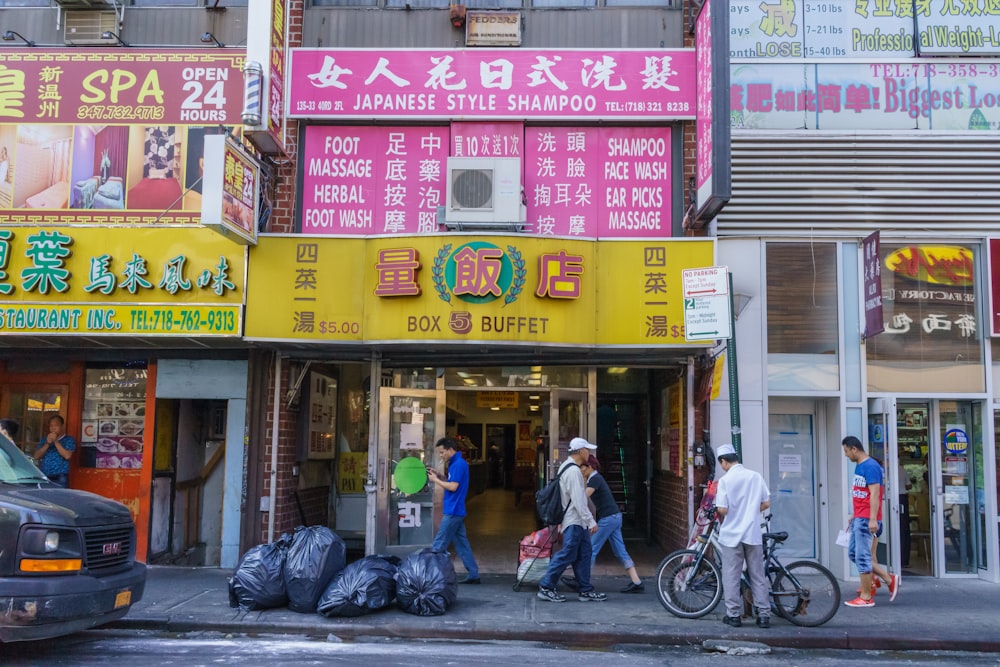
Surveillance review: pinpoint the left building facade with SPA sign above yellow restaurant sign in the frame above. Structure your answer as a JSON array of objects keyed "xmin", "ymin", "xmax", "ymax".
[{"xmin": 0, "ymin": 14, "xmax": 254, "ymax": 567}]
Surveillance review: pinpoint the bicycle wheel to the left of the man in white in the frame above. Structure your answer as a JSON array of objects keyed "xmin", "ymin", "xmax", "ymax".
[{"xmin": 656, "ymin": 549, "xmax": 722, "ymax": 618}]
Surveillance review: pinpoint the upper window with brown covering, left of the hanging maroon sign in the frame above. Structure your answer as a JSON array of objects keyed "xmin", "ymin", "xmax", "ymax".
[{"xmin": 767, "ymin": 243, "xmax": 840, "ymax": 391}]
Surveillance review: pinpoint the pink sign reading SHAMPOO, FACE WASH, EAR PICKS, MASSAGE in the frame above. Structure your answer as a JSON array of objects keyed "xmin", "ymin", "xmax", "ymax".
[{"xmin": 524, "ymin": 127, "xmax": 671, "ymax": 239}]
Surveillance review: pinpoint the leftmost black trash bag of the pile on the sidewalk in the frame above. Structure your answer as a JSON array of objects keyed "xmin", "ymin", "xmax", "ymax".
[{"xmin": 229, "ymin": 533, "xmax": 292, "ymax": 611}]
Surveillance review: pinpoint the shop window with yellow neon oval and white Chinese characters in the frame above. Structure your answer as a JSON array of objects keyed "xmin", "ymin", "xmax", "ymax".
[{"xmin": 865, "ymin": 240, "xmax": 986, "ymax": 392}]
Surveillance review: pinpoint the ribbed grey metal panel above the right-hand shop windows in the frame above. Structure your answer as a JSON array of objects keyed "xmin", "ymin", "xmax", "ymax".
[{"xmin": 717, "ymin": 131, "xmax": 1000, "ymax": 237}]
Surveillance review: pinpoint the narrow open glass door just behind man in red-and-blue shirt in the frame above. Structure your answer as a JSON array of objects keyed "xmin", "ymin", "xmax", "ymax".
[{"xmin": 868, "ymin": 398, "xmax": 909, "ymax": 572}]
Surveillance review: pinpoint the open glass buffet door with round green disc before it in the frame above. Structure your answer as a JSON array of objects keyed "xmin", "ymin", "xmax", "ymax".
[{"xmin": 375, "ymin": 387, "xmax": 444, "ymax": 556}]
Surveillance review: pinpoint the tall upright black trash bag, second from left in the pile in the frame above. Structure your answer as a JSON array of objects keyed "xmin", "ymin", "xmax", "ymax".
[{"xmin": 285, "ymin": 526, "xmax": 347, "ymax": 614}]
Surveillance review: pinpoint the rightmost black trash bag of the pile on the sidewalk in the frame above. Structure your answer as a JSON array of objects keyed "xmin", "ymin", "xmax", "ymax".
[{"xmin": 396, "ymin": 548, "xmax": 458, "ymax": 616}]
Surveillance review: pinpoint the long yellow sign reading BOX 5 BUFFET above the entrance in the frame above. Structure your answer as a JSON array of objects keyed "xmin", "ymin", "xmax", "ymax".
[{"xmin": 246, "ymin": 235, "xmax": 715, "ymax": 346}]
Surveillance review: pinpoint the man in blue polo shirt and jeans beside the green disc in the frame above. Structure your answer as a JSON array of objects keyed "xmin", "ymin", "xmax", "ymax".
[{"xmin": 427, "ymin": 438, "xmax": 480, "ymax": 584}]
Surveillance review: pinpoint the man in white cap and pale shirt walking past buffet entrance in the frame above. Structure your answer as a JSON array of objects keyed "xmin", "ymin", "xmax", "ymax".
[{"xmin": 538, "ymin": 438, "xmax": 608, "ymax": 602}]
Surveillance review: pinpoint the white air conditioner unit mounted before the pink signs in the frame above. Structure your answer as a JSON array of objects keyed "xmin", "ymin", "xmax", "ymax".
[{"xmin": 444, "ymin": 157, "xmax": 525, "ymax": 223}]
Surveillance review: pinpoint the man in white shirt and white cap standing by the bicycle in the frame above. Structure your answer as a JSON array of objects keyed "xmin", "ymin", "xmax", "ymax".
[{"xmin": 715, "ymin": 444, "xmax": 771, "ymax": 628}]
